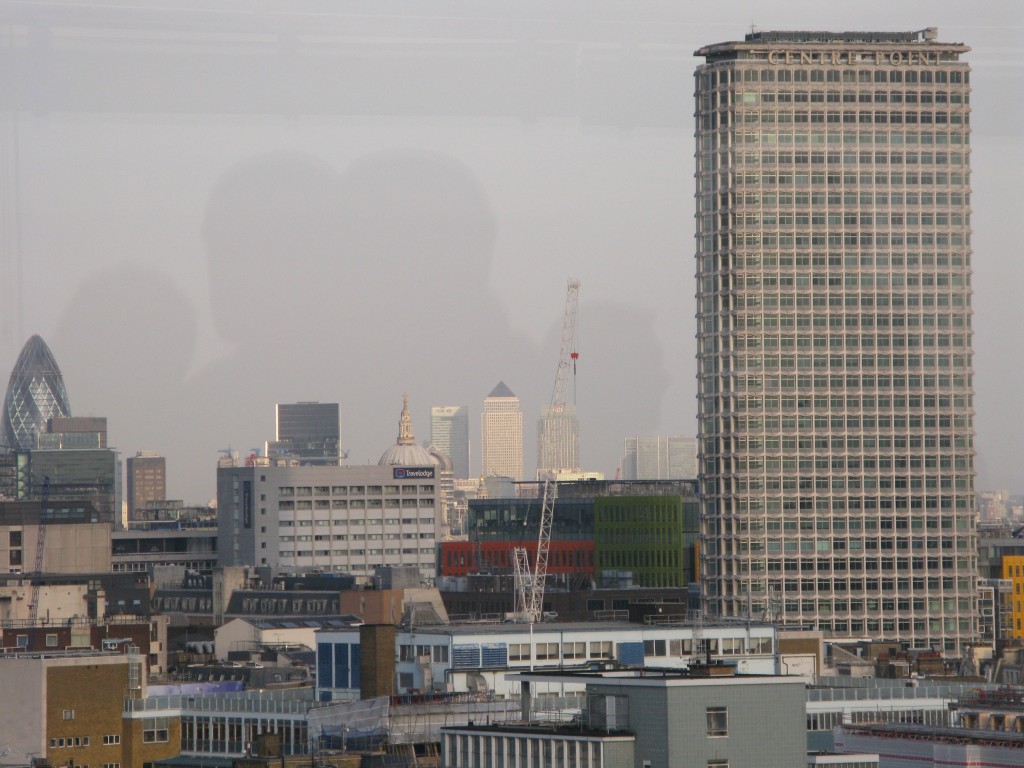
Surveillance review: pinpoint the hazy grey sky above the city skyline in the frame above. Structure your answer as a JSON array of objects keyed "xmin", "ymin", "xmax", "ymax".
[{"xmin": 0, "ymin": 0, "xmax": 1024, "ymax": 502}]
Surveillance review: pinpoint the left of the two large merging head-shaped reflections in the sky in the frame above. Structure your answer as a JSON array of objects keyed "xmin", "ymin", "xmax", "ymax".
[{"xmin": 203, "ymin": 153, "xmax": 341, "ymax": 340}]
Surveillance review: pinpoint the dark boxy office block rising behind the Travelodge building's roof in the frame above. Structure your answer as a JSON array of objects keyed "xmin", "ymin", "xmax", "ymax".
[{"xmin": 266, "ymin": 402, "xmax": 342, "ymax": 466}]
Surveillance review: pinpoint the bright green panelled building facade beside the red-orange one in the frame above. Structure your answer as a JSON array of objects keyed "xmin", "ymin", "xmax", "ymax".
[{"xmin": 594, "ymin": 493, "xmax": 700, "ymax": 587}]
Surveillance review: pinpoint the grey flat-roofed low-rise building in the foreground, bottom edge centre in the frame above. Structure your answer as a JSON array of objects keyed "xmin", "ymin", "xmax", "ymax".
[{"xmin": 441, "ymin": 666, "xmax": 807, "ymax": 768}]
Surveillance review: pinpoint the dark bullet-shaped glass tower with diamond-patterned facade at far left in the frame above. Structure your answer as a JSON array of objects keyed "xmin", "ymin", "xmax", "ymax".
[{"xmin": 2, "ymin": 336, "xmax": 71, "ymax": 451}]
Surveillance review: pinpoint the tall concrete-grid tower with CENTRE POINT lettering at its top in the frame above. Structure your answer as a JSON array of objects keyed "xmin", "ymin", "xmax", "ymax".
[{"xmin": 695, "ymin": 29, "xmax": 977, "ymax": 653}]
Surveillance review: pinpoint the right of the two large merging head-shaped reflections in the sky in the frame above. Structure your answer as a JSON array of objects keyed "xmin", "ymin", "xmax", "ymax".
[{"xmin": 342, "ymin": 150, "xmax": 495, "ymax": 290}]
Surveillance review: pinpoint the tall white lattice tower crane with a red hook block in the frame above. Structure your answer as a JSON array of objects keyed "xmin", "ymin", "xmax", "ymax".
[{"xmin": 512, "ymin": 280, "xmax": 580, "ymax": 624}]
